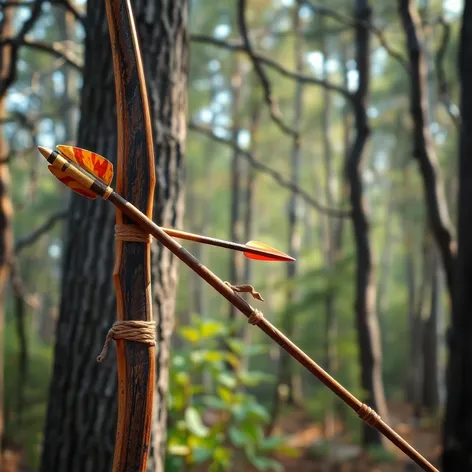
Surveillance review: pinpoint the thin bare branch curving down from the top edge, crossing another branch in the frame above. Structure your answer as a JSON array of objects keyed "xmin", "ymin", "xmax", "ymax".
[{"xmin": 238, "ymin": 0, "xmax": 298, "ymax": 139}]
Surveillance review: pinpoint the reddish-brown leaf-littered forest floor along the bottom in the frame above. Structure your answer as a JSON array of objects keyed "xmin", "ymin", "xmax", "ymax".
[{"xmin": 0, "ymin": 404, "xmax": 441, "ymax": 472}]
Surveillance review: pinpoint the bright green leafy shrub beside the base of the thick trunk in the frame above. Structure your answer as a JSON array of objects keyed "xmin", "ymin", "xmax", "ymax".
[{"xmin": 166, "ymin": 316, "xmax": 290, "ymax": 472}]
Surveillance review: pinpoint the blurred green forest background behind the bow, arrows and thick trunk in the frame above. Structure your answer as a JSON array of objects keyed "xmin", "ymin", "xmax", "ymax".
[{"xmin": 0, "ymin": 0, "xmax": 472, "ymax": 472}]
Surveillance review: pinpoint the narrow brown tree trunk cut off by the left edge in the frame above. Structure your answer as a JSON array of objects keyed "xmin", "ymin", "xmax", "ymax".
[{"xmin": 0, "ymin": 2, "xmax": 14, "ymax": 454}]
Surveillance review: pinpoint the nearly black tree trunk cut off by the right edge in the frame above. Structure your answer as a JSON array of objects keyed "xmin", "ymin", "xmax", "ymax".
[{"xmin": 441, "ymin": 1, "xmax": 472, "ymax": 472}]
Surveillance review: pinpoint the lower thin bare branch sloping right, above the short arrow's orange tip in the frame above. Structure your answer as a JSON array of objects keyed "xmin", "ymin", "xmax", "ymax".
[{"xmin": 189, "ymin": 122, "xmax": 351, "ymax": 218}]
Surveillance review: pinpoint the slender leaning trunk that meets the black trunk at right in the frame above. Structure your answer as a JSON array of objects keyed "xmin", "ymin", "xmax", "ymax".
[{"xmin": 398, "ymin": 0, "xmax": 456, "ymax": 299}]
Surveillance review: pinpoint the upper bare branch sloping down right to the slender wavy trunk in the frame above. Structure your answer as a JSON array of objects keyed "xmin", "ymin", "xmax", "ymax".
[{"xmin": 190, "ymin": 34, "xmax": 352, "ymax": 102}]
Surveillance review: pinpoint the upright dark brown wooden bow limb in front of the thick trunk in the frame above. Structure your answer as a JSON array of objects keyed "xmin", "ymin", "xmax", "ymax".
[{"xmin": 105, "ymin": 0, "xmax": 155, "ymax": 472}]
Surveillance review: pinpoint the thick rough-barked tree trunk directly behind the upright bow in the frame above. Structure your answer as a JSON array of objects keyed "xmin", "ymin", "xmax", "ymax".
[{"xmin": 41, "ymin": 0, "xmax": 187, "ymax": 472}]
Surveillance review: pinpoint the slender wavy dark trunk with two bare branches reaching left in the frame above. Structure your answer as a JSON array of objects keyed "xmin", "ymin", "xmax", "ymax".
[{"xmin": 346, "ymin": 0, "xmax": 388, "ymax": 445}]
